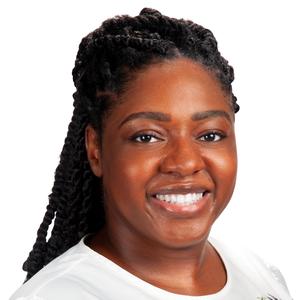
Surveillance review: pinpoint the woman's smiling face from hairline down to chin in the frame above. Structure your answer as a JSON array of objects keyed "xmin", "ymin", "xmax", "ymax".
[{"xmin": 87, "ymin": 58, "xmax": 237, "ymax": 248}]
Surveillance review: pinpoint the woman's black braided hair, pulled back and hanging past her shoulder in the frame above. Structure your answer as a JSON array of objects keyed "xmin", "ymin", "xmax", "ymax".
[{"xmin": 23, "ymin": 8, "xmax": 239, "ymax": 280}]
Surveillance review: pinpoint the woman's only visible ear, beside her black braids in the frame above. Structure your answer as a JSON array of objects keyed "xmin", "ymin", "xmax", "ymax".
[{"xmin": 85, "ymin": 125, "xmax": 102, "ymax": 177}]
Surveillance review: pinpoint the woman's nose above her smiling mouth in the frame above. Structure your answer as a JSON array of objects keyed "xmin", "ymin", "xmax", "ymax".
[{"xmin": 160, "ymin": 140, "xmax": 205, "ymax": 177}]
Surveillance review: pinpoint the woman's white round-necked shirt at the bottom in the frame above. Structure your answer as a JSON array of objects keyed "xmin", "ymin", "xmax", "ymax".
[{"xmin": 10, "ymin": 239, "xmax": 292, "ymax": 300}]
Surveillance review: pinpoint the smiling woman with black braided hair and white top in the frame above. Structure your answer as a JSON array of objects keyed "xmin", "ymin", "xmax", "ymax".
[{"xmin": 11, "ymin": 8, "xmax": 291, "ymax": 300}]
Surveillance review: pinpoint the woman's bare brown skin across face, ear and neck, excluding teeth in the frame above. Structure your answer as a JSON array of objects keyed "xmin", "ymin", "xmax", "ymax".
[{"xmin": 86, "ymin": 58, "xmax": 237, "ymax": 295}]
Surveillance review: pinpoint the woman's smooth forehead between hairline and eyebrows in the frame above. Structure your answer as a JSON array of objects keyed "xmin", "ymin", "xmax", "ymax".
[{"xmin": 111, "ymin": 58, "xmax": 233, "ymax": 122}]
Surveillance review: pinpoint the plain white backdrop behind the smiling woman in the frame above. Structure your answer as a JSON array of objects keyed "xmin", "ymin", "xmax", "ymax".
[{"xmin": 0, "ymin": 0, "xmax": 300, "ymax": 299}]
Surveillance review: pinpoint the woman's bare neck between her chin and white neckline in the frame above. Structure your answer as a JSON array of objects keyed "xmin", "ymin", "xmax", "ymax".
[{"xmin": 89, "ymin": 227, "xmax": 226, "ymax": 295}]
